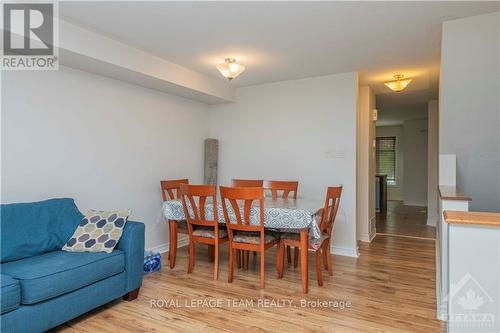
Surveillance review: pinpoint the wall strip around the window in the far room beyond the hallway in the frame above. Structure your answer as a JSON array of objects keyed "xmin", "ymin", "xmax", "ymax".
[{"xmin": 376, "ymin": 125, "xmax": 404, "ymax": 201}]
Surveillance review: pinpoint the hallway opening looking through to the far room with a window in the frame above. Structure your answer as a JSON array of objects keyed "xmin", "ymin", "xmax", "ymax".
[{"xmin": 375, "ymin": 105, "xmax": 436, "ymax": 239}]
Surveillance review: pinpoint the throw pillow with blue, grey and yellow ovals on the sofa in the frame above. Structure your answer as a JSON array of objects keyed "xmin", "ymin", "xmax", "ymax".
[{"xmin": 62, "ymin": 210, "xmax": 130, "ymax": 253}]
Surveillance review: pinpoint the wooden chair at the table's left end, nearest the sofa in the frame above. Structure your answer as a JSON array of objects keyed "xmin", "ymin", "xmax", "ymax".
[{"xmin": 160, "ymin": 179, "xmax": 189, "ymax": 268}]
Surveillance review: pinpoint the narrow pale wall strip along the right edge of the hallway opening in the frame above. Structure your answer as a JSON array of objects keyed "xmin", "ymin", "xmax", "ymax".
[{"xmin": 427, "ymin": 100, "xmax": 439, "ymax": 226}]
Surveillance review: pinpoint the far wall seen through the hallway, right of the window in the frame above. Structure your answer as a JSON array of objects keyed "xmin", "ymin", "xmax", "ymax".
[{"xmin": 403, "ymin": 119, "xmax": 428, "ymax": 206}]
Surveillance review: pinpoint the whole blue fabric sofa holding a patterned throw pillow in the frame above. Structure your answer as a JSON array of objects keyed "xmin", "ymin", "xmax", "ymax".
[{"xmin": 0, "ymin": 199, "xmax": 144, "ymax": 332}]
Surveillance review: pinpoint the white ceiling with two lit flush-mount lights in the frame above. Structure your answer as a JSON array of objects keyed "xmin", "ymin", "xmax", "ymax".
[{"xmin": 59, "ymin": 2, "xmax": 500, "ymax": 113}]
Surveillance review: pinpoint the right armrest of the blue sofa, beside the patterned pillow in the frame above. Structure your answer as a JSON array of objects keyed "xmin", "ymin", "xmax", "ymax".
[{"xmin": 116, "ymin": 221, "xmax": 145, "ymax": 292}]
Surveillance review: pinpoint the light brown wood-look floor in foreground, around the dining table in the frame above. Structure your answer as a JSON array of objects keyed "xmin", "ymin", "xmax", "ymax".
[{"xmin": 54, "ymin": 235, "xmax": 445, "ymax": 333}]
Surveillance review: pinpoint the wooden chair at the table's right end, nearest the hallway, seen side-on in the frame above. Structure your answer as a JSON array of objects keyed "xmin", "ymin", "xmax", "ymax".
[{"xmin": 277, "ymin": 186, "xmax": 342, "ymax": 286}]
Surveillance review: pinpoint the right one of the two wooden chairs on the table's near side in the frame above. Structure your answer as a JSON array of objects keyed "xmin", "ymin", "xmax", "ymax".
[{"xmin": 220, "ymin": 186, "xmax": 278, "ymax": 288}]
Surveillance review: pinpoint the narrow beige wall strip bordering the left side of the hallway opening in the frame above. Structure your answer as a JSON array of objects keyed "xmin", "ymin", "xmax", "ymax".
[{"xmin": 356, "ymin": 86, "xmax": 376, "ymax": 242}]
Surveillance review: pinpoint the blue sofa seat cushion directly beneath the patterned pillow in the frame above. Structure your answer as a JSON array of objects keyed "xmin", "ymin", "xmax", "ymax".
[{"xmin": 2, "ymin": 250, "xmax": 125, "ymax": 304}]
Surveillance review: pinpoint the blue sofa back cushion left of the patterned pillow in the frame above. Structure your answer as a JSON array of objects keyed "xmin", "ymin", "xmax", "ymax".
[{"xmin": 0, "ymin": 198, "xmax": 83, "ymax": 263}]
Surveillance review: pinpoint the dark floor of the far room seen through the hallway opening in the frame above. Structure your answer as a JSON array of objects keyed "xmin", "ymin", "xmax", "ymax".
[{"xmin": 377, "ymin": 201, "xmax": 436, "ymax": 239}]
